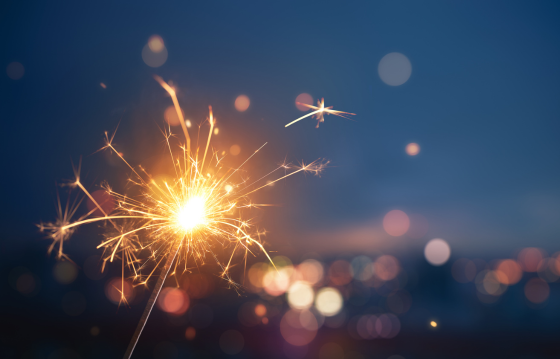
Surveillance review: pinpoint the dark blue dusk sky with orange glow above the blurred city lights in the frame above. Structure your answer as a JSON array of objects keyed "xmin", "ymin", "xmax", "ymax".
[{"xmin": 0, "ymin": 1, "xmax": 560, "ymax": 255}]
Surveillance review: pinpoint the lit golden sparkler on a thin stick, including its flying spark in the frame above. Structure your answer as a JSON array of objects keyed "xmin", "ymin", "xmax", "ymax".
[{"xmin": 39, "ymin": 76, "xmax": 332, "ymax": 358}]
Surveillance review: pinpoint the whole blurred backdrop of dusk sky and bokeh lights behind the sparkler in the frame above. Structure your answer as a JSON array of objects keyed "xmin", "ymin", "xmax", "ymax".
[{"xmin": 0, "ymin": 1, "xmax": 560, "ymax": 359}]
